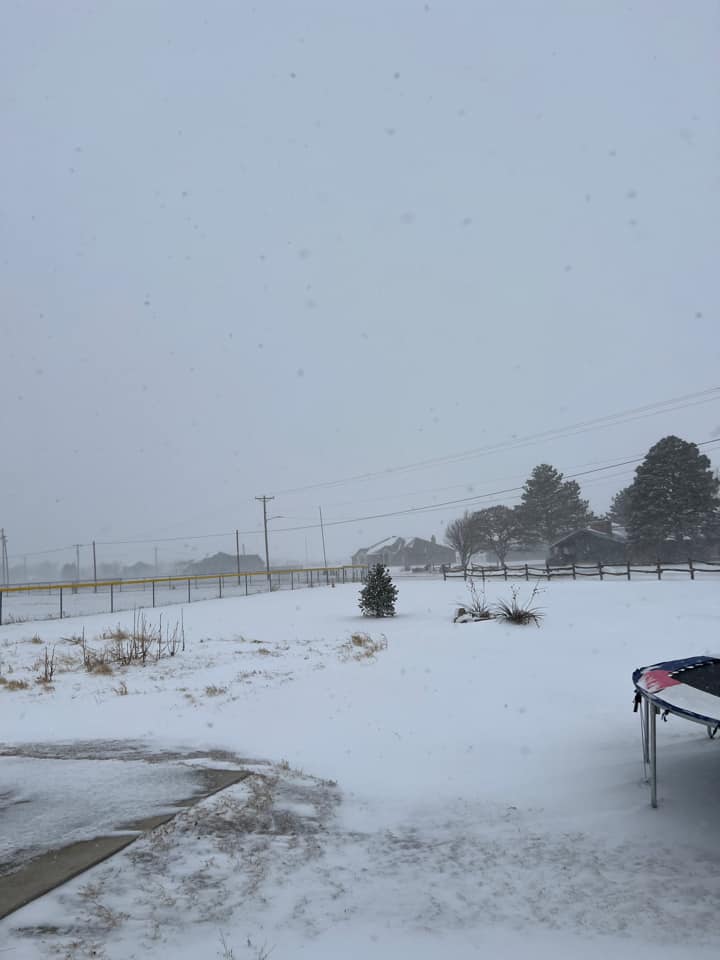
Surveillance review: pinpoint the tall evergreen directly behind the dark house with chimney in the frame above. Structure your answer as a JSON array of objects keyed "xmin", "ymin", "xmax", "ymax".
[{"xmin": 516, "ymin": 463, "xmax": 592, "ymax": 543}]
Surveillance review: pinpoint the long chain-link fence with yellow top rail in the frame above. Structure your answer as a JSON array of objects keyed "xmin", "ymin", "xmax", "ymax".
[{"xmin": 0, "ymin": 564, "xmax": 367, "ymax": 625}]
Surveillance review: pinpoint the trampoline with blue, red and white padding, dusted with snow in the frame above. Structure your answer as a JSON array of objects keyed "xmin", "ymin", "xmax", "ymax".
[{"xmin": 633, "ymin": 656, "xmax": 720, "ymax": 807}]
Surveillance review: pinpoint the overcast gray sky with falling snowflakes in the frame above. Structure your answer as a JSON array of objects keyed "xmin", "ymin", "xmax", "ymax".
[{"xmin": 0, "ymin": 0, "xmax": 720, "ymax": 560}]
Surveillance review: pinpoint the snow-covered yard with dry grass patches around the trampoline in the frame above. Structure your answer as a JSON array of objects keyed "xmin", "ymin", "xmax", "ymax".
[{"xmin": 0, "ymin": 581, "xmax": 720, "ymax": 960}]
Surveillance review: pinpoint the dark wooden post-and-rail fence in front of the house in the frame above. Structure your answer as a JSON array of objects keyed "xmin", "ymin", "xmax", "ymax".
[{"xmin": 443, "ymin": 560, "xmax": 720, "ymax": 583}]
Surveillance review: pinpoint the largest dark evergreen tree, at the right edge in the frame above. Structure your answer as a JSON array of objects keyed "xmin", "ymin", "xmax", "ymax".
[{"xmin": 628, "ymin": 436, "xmax": 718, "ymax": 557}]
